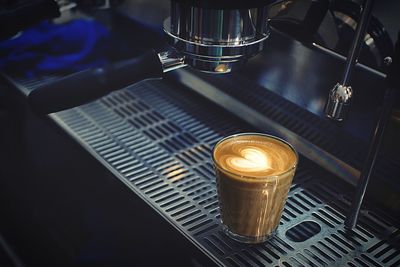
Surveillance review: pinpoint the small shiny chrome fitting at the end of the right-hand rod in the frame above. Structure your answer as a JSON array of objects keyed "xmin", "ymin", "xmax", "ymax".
[{"xmin": 325, "ymin": 83, "xmax": 353, "ymax": 121}]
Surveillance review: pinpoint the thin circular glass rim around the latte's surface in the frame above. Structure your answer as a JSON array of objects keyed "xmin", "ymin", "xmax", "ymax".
[{"xmin": 212, "ymin": 132, "xmax": 299, "ymax": 180}]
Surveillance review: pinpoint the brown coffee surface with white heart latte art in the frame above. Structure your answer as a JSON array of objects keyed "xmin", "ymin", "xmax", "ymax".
[{"xmin": 214, "ymin": 135, "xmax": 296, "ymax": 177}]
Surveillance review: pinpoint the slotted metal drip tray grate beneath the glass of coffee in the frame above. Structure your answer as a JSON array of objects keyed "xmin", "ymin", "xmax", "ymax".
[{"xmin": 51, "ymin": 81, "xmax": 400, "ymax": 266}]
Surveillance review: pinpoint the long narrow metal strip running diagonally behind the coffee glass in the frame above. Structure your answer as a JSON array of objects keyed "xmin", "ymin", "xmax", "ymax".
[{"xmin": 175, "ymin": 70, "xmax": 360, "ymax": 185}]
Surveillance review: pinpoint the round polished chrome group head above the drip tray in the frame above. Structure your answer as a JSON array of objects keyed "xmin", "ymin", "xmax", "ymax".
[{"xmin": 164, "ymin": 1, "xmax": 270, "ymax": 73}]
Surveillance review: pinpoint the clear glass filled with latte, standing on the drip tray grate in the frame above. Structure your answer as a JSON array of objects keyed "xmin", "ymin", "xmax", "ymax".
[{"xmin": 212, "ymin": 133, "xmax": 298, "ymax": 243}]
